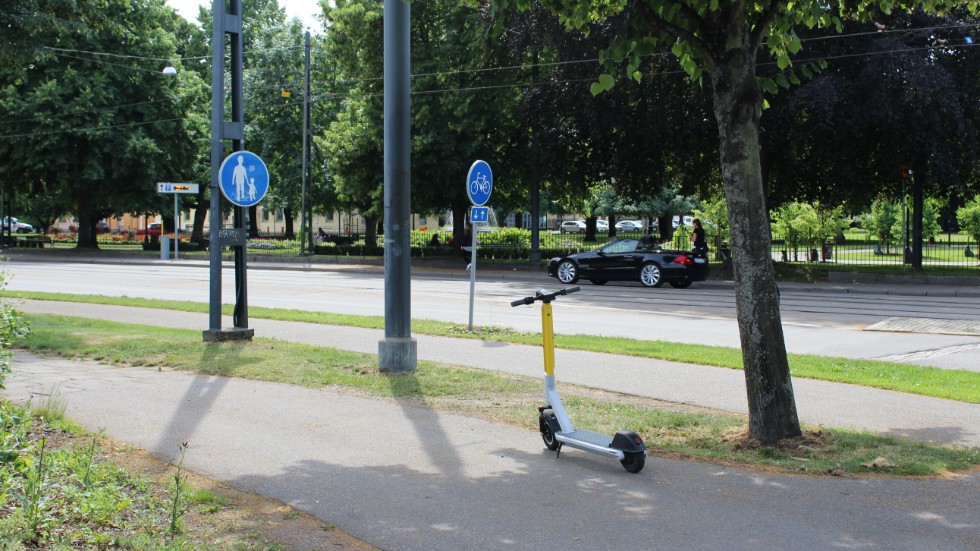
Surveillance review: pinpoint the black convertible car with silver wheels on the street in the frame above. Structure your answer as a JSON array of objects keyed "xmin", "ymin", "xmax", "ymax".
[{"xmin": 548, "ymin": 239, "xmax": 708, "ymax": 289}]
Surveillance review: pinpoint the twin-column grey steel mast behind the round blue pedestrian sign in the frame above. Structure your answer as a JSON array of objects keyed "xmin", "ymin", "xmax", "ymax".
[{"xmin": 204, "ymin": 0, "xmax": 255, "ymax": 342}]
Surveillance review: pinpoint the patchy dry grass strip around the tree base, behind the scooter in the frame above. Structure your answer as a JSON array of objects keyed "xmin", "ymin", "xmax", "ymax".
[{"xmin": 19, "ymin": 314, "xmax": 980, "ymax": 475}]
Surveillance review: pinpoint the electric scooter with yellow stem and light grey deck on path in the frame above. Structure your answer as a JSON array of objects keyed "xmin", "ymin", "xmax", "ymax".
[{"xmin": 510, "ymin": 287, "xmax": 647, "ymax": 473}]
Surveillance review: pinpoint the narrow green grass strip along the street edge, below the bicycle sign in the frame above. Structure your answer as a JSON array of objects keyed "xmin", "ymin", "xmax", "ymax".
[{"xmin": 7, "ymin": 291, "xmax": 980, "ymax": 404}]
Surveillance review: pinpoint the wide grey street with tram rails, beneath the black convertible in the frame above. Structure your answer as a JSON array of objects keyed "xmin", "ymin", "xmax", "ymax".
[{"xmin": 7, "ymin": 258, "xmax": 980, "ymax": 371}]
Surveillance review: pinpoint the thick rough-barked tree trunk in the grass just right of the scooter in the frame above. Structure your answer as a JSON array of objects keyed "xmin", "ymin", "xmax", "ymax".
[{"xmin": 711, "ymin": 38, "xmax": 800, "ymax": 443}]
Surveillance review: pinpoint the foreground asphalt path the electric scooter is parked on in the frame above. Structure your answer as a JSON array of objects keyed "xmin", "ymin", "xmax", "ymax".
[{"xmin": 5, "ymin": 353, "xmax": 980, "ymax": 551}]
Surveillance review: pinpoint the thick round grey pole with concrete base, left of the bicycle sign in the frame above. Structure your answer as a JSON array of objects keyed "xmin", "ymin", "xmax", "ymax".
[{"xmin": 378, "ymin": 0, "xmax": 417, "ymax": 372}]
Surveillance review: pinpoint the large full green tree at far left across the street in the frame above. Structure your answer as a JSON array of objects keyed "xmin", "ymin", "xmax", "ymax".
[{"xmin": 0, "ymin": 0, "xmax": 208, "ymax": 247}]
